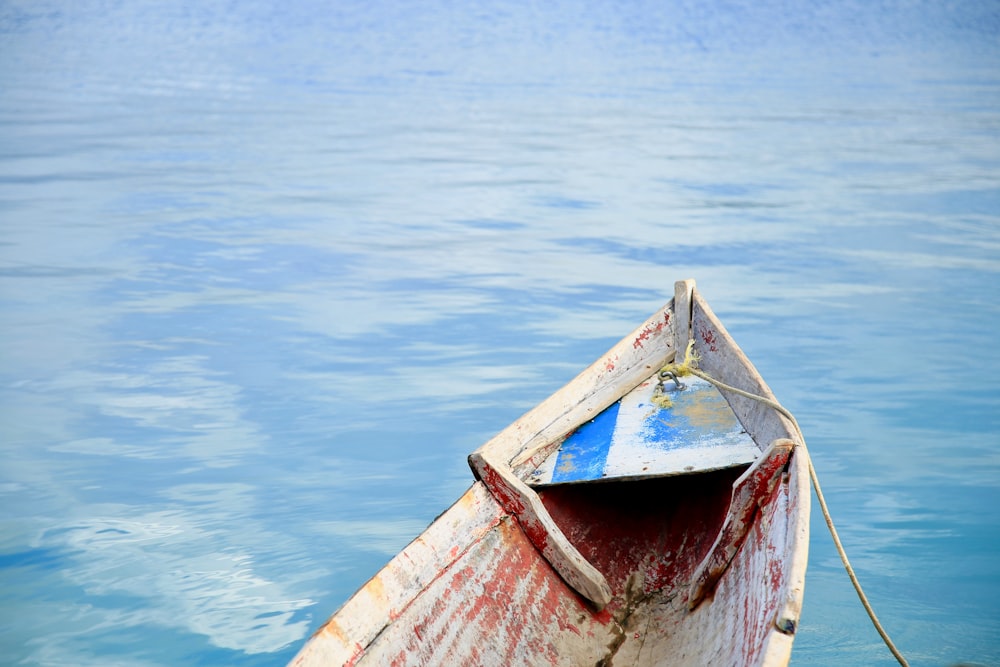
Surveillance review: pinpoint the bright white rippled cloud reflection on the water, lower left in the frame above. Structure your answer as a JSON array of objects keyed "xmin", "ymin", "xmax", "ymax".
[{"xmin": 38, "ymin": 508, "xmax": 312, "ymax": 653}]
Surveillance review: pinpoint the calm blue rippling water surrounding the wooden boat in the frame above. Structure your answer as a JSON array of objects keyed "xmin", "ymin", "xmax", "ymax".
[{"xmin": 0, "ymin": 0, "xmax": 1000, "ymax": 666}]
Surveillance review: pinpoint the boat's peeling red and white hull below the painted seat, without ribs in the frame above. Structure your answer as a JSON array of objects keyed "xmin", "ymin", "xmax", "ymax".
[{"xmin": 292, "ymin": 455, "xmax": 808, "ymax": 667}]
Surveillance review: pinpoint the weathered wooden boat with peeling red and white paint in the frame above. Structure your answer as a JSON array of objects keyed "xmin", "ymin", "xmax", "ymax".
[{"xmin": 290, "ymin": 280, "xmax": 810, "ymax": 667}]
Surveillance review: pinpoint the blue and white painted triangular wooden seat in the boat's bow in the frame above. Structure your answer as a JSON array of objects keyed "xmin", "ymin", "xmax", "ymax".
[{"xmin": 525, "ymin": 375, "xmax": 760, "ymax": 487}]
